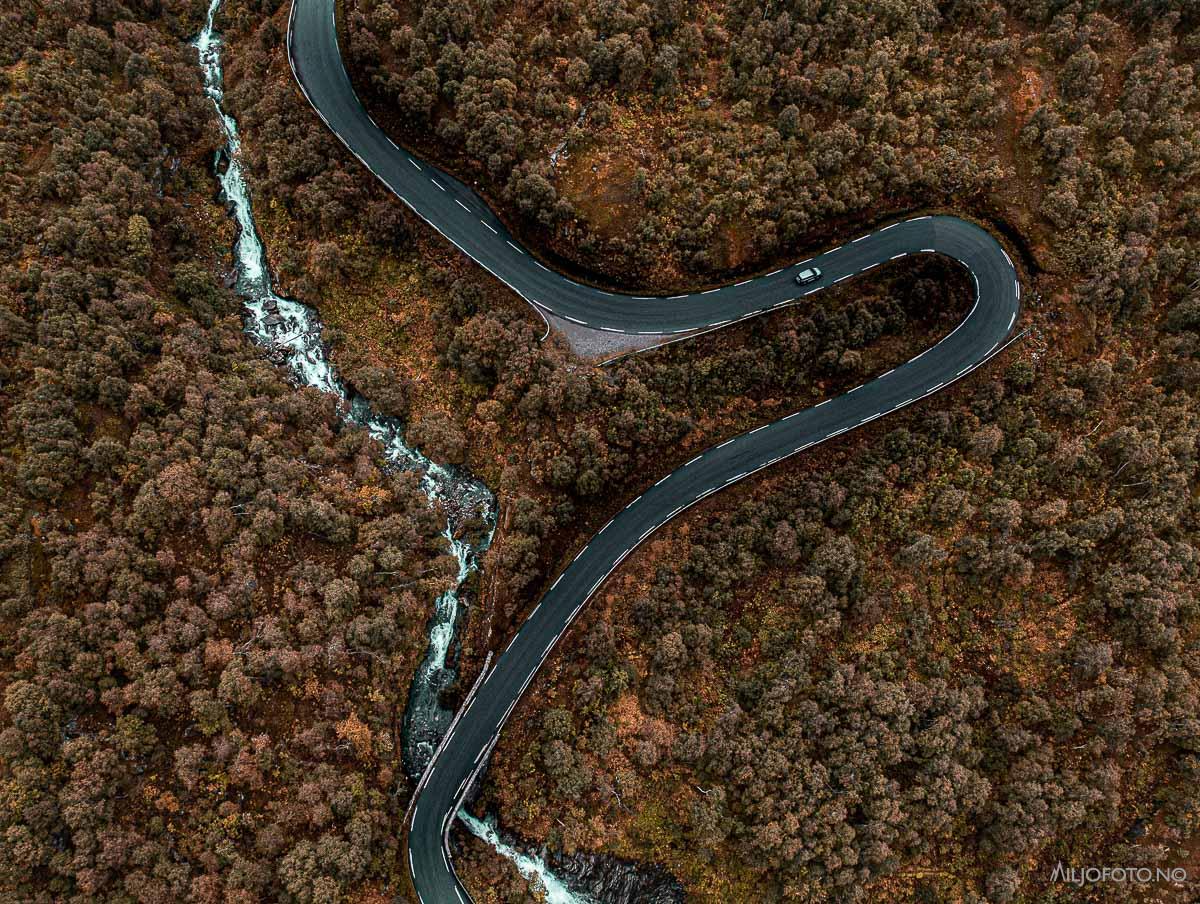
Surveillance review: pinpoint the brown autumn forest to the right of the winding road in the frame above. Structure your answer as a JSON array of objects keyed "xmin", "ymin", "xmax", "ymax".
[{"xmin": 331, "ymin": 0, "xmax": 1200, "ymax": 900}]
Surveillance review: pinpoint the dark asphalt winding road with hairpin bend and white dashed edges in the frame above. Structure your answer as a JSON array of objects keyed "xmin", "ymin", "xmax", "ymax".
[{"xmin": 287, "ymin": 0, "xmax": 1021, "ymax": 904}]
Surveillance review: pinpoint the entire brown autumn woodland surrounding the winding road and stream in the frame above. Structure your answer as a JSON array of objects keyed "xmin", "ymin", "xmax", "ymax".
[{"xmin": 0, "ymin": 0, "xmax": 1200, "ymax": 904}]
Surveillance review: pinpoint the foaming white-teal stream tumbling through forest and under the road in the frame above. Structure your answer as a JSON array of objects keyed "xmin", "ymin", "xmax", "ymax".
[{"xmin": 194, "ymin": 0, "xmax": 681, "ymax": 904}]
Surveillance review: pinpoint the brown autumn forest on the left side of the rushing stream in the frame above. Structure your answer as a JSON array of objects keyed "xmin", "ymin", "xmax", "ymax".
[{"xmin": 0, "ymin": 4, "xmax": 456, "ymax": 904}]
